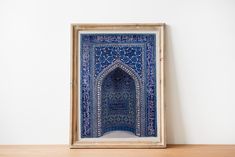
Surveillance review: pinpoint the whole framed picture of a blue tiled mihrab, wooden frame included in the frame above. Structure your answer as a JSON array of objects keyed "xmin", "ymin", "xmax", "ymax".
[{"xmin": 70, "ymin": 24, "xmax": 166, "ymax": 148}]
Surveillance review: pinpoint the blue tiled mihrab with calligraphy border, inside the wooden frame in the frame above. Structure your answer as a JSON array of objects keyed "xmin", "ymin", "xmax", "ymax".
[{"xmin": 79, "ymin": 32, "xmax": 158, "ymax": 138}]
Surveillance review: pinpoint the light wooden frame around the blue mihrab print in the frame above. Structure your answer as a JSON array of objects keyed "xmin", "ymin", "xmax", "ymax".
[{"xmin": 70, "ymin": 23, "xmax": 167, "ymax": 149}]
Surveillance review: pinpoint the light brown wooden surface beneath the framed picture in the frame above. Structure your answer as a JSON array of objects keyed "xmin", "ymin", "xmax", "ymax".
[{"xmin": 0, "ymin": 145, "xmax": 235, "ymax": 157}]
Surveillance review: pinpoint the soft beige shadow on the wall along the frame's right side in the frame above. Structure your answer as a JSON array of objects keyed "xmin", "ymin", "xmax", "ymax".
[{"xmin": 165, "ymin": 25, "xmax": 186, "ymax": 144}]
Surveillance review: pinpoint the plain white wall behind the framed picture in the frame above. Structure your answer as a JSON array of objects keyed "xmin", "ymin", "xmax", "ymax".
[{"xmin": 0, "ymin": 0, "xmax": 235, "ymax": 144}]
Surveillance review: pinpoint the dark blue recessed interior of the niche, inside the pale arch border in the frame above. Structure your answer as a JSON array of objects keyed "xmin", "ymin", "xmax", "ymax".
[{"xmin": 101, "ymin": 68, "xmax": 136, "ymax": 137}]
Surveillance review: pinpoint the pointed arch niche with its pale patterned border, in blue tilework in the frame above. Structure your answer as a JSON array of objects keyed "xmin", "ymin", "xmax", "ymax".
[{"xmin": 96, "ymin": 60, "xmax": 141, "ymax": 137}]
